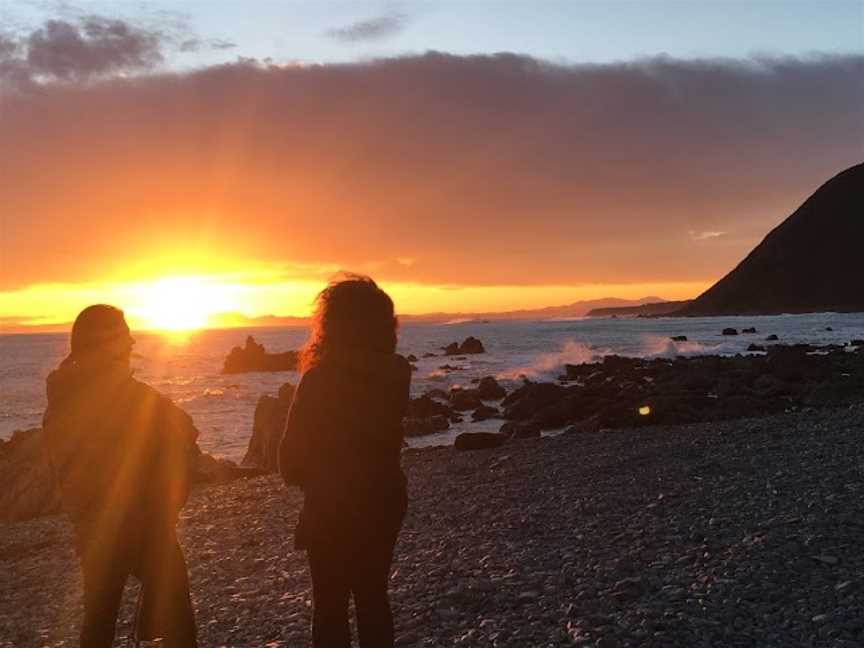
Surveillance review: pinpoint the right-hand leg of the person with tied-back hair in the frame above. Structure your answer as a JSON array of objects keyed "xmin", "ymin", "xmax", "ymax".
[{"xmin": 136, "ymin": 529, "xmax": 198, "ymax": 648}]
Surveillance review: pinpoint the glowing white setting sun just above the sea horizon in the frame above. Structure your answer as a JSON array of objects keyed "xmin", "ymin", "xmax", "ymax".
[{"xmin": 128, "ymin": 277, "xmax": 230, "ymax": 331}]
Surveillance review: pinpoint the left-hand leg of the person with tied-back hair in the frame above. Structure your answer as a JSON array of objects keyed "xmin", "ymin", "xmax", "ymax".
[{"xmin": 78, "ymin": 539, "xmax": 131, "ymax": 648}]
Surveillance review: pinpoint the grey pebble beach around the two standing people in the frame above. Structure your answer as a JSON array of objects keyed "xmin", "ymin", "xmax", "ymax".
[{"xmin": 0, "ymin": 405, "xmax": 864, "ymax": 648}]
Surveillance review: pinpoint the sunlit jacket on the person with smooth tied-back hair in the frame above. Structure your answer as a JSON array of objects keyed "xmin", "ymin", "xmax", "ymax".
[{"xmin": 43, "ymin": 361, "xmax": 198, "ymax": 534}]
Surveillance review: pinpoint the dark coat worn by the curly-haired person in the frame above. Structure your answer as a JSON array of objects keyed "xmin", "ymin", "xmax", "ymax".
[{"xmin": 279, "ymin": 351, "xmax": 411, "ymax": 549}]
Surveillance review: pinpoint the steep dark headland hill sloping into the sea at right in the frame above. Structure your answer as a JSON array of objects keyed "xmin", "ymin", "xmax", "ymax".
[{"xmin": 676, "ymin": 164, "xmax": 864, "ymax": 316}]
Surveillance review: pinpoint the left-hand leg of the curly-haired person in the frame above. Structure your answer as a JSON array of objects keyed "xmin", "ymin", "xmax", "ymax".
[{"xmin": 308, "ymin": 546, "xmax": 351, "ymax": 648}]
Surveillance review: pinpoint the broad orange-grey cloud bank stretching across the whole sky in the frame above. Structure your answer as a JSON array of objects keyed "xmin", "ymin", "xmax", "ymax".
[{"xmin": 0, "ymin": 53, "xmax": 864, "ymax": 288}]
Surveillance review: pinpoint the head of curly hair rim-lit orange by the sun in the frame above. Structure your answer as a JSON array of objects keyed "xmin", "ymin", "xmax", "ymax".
[{"xmin": 300, "ymin": 274, "xmax": 398, "ymax": 371}]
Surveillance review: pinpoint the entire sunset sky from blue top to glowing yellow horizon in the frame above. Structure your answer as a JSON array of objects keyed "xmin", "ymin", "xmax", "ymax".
[{"xmin": 0, "ymin": 0, "xmax": 864, "ymax": 332}]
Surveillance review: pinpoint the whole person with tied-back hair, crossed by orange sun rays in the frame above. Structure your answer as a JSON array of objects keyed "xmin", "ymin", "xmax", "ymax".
[{"xmin": 43, "ymin": 305, "xmax": 198, "ymax": 648}]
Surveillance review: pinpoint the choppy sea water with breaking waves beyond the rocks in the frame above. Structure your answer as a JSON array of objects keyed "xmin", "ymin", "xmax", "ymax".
[{"xmin": 0, "ymin": 313, "xmax": 864, "ymax": 460}]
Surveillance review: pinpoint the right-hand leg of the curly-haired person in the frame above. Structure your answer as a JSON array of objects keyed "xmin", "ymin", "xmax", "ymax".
[{"xmin": 351, "ymin": 534, "xmax": 396, "ymax": 648}]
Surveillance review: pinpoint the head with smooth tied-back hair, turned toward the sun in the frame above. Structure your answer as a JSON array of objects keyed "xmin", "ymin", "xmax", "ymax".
[{"xmin": 69, "ymin": 304, "xmax": 135, "ymax": 366}]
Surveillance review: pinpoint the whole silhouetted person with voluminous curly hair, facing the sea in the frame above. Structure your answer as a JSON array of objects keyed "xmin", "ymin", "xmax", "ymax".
[{"xmin": 279, "ymin": 275, "xmax": 411, "ymax": 648}]
